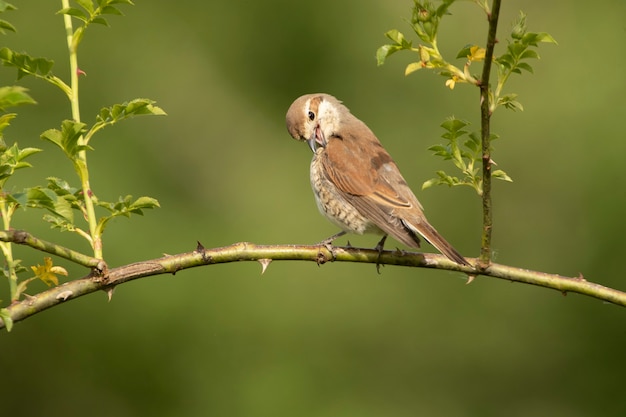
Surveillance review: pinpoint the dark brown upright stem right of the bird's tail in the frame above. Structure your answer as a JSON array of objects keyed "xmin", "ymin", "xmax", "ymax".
[{"xmin": 479, "ymin": 0, "xmax": 500, "ymax": 268}]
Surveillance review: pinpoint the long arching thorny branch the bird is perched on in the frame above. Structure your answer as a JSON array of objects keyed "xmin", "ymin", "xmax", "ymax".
[{"xmin": 0, "ymin": 242, "xmax": 626, "ymax": 328}]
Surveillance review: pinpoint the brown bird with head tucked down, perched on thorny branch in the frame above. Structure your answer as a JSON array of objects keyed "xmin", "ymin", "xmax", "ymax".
[{"xmin": 287, "ymin": 93, "xmax": 469, "ymax": 265}]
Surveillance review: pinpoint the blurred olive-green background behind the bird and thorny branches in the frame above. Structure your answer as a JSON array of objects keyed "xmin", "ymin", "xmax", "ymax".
[{"xmin": 0, "ymin": 0, "xmax": 626, "ymax": 417}]
